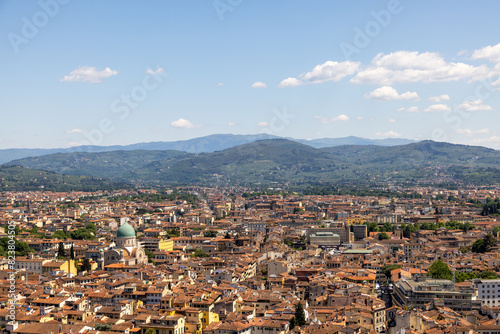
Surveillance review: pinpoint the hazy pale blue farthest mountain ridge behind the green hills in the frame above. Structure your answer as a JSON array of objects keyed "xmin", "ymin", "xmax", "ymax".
[{"xmin": 0, "ymin": 133, "xmax": 414, "ymax": 164}]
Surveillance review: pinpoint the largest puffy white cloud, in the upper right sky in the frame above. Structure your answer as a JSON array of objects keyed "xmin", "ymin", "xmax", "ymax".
[{"xmin": 351, "ymin": 51, "xmax": 495, "ymax": 85}]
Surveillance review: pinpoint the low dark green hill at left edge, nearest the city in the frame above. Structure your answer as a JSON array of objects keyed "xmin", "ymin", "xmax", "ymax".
[{"xmin": 0, "ymin": 166, "xmax": 132, "ymax": 191}]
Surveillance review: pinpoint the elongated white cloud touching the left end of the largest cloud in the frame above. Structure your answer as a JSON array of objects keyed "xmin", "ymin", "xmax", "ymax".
[{"xmin": 278, "ymin": 60, "xmax": 361, "ymax": 88}]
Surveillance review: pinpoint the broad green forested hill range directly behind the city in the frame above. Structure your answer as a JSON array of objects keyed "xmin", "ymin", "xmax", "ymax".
[{"xmin": 6, "ymin": 139, "xmax": 500, "ymax": 185}]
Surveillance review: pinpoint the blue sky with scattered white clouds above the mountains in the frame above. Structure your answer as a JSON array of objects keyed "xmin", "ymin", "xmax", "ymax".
[{"xmin": 0, "ymin": 0, "xmax": 500, "ymax": 149}]
